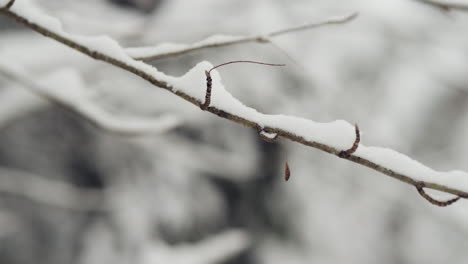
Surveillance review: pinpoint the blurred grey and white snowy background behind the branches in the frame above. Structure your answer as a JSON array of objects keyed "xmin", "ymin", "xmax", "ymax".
[{"xmin": 0, "ymin": 0, "xmax": 468, "ymax": 264}]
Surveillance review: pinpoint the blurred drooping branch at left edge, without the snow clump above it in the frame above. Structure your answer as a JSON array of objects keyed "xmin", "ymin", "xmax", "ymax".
[{"xmin": 0, "ymin": 64, "xmax": 181, "ymax": 136}]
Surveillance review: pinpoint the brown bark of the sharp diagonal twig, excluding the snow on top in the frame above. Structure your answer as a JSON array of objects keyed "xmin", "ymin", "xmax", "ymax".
[{"xmin": 0, "ymin": 6, "xmax": 468, "ymax": 199}]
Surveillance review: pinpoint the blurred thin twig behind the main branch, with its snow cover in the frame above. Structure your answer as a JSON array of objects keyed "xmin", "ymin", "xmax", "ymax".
[{"xmin": 125, "ymin": 13, "xmax": 357, "ymax": 61}]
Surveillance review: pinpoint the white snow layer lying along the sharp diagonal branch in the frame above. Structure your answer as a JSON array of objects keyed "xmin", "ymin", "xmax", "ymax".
[{"xmin": 3, "ymin": 0, "xmax": 468, "ymax": 192}]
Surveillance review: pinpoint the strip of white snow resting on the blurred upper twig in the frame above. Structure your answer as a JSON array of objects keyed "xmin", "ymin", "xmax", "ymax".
[{"xmin": 125, "ymin": 35, "xmax": 245, "ymax": 58}]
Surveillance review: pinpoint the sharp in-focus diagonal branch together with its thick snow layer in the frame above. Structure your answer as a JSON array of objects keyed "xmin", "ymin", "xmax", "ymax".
[{"xmin": 0, "ymin": 0, "xmax": 468, "ymax": 204}]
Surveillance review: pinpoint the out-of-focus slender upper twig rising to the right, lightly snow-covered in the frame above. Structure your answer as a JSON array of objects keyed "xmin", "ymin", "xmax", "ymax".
[{"xmin": 127, "ymin": 12, "xmax": 358, "ymax": 61}]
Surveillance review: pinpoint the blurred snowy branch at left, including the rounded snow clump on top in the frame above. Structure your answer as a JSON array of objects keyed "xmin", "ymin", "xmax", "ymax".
[{"xmin": 0, "ymin": 62, "xmax": 182, "ymax": 135}]
